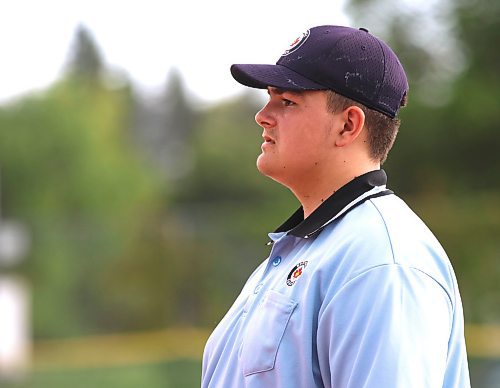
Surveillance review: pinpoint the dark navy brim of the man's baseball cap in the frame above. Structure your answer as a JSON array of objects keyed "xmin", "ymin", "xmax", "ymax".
[{"xmin": 231, "ymin": 64, "xmax": 328, "ymax": 90}]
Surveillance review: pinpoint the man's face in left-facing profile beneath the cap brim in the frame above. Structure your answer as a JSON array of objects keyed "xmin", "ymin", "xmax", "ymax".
[{"xmin": 255, "ymin": 87, "xmax": 338, "ymax": 187}]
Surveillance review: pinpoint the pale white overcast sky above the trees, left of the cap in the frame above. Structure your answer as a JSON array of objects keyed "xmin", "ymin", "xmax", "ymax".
[{"xmin": 0, "ymin": 0, "xmax": 349, "ymax": 103}]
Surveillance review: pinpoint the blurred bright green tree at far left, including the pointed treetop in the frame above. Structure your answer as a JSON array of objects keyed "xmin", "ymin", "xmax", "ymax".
[{"xmin": 0, "ymin": 26, "xmax": 165, "ymax": 337}]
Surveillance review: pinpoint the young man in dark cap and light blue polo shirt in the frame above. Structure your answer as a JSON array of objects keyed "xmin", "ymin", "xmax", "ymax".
[{"xmin": 202, "ymin": 26, "xmax": 470, "ymax": 388}]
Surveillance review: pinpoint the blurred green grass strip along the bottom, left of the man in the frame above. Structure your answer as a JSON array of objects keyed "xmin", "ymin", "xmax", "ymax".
[{"xmin": 0, "ymin": 360, "xmax": 201, "ymax": 388}]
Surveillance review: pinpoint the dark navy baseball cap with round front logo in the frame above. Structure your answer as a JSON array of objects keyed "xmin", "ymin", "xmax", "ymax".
[{"xmin": 231, "ymin": 25, "xmax": 408, "ymax": 118}]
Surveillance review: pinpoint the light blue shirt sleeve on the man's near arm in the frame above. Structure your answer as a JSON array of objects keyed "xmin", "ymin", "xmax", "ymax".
[{"xmin": 317, "ymin": 264, "xmax": 453, "ymax": 388}]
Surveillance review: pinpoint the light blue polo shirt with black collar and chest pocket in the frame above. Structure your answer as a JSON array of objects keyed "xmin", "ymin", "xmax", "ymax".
[{"xmin": 201, "ymin": 170, "xmax": 470, "ymax": 388}]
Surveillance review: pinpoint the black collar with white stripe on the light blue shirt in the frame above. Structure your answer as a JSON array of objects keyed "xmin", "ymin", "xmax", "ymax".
[{"xmin": 275, "ymin": 170, "xmax": 393, "ymax": 238}]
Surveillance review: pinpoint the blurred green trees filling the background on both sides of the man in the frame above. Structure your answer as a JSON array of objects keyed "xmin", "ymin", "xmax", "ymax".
[{"xmin": 0, "ymin": 0, "xmax": 500, "ymax": 387}]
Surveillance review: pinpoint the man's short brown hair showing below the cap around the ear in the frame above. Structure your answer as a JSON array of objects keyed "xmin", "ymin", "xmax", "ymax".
[{"xmin": 327, "ymin": 90, "xmax": 406, "ymax": 164}]
